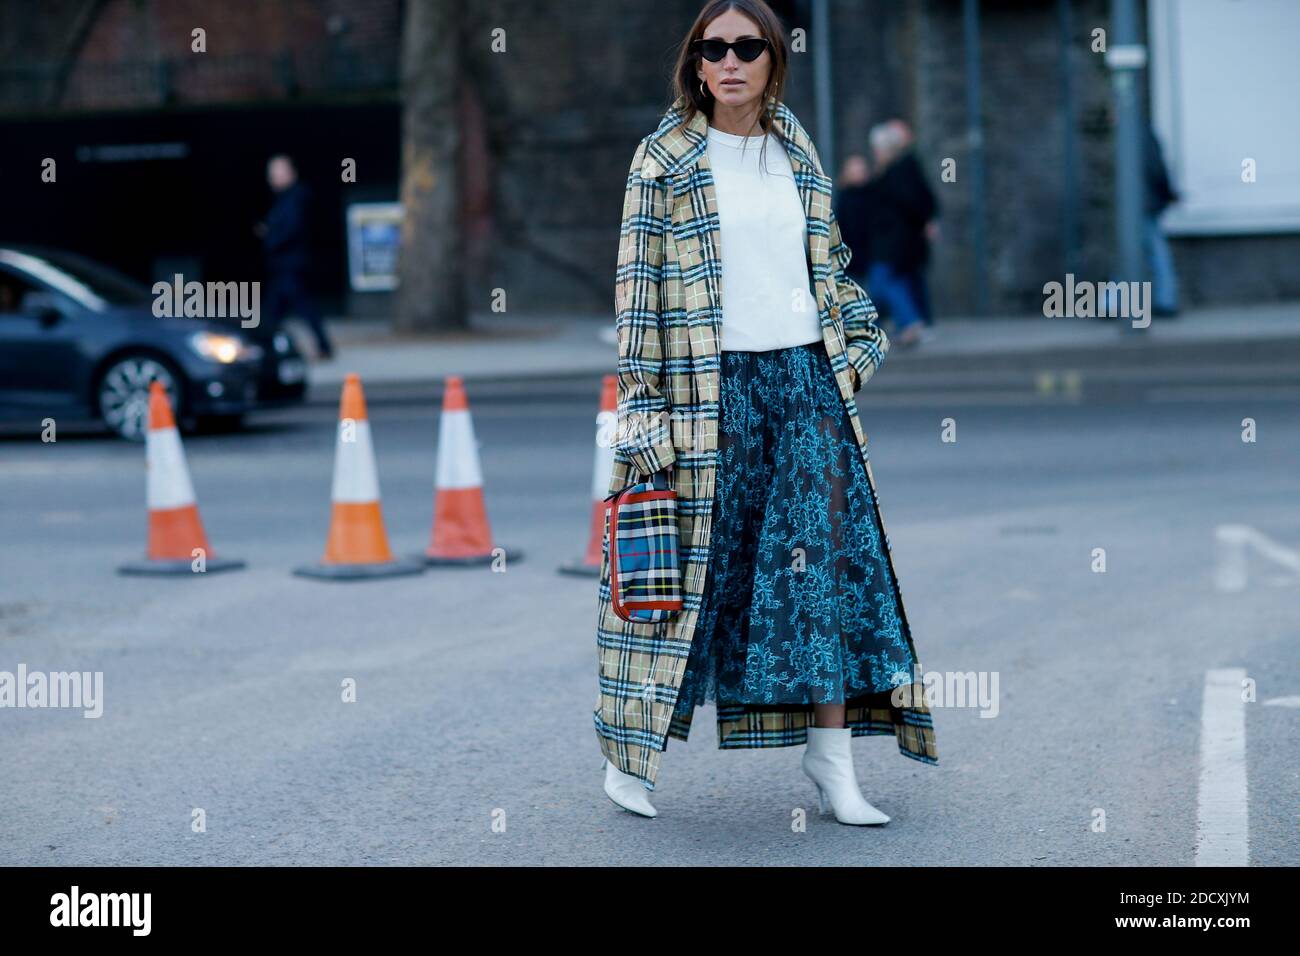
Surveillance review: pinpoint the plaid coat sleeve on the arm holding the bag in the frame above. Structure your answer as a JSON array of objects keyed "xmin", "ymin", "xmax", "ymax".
[{"xmin": 614, "ymin": 139, "xmax": 676, "ymax": 475}]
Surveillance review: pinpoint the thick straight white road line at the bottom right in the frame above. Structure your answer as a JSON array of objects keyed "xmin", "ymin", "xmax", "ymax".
[{"xmin": 1196, "ymin": 667, "xmax": 1249, "ymax": 866}]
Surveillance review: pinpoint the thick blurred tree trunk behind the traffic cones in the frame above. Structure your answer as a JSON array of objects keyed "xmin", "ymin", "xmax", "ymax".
[{"xmin": 395, "ymin": 0, "xmax": 469, "ymax": 330}]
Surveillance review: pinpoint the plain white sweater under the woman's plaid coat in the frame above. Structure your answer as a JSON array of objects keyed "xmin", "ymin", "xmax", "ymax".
[{"xmin": 707, "ymin": 126, "xmax": 822, "ymax": 351}]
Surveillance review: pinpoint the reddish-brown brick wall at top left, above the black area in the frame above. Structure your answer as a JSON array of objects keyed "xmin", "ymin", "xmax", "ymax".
[{"xmin": 0, "ymin": 0, "xmax": 400, "ymax": 114}]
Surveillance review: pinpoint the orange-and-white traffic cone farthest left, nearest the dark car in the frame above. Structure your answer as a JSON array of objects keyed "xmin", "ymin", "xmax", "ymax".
[{"xmin": 117, "ymin": 380, "xmax": 244, "ymax": 575}]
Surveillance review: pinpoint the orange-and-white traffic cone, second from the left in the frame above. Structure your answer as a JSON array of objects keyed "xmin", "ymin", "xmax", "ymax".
[{"xmin": 294, "ymin": 372, "xmax": 424, "ymax": 580}]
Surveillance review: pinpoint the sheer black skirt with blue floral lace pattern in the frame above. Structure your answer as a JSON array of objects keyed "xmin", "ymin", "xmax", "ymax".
[{"xmin": 676, "ymin": 342, "xmax": 914, "ymax": 714}]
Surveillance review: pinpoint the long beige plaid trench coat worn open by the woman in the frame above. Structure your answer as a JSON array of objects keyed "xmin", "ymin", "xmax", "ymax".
[{"xmin": 593, "ymin": 98, "xmax": 939, "ymax": 791}]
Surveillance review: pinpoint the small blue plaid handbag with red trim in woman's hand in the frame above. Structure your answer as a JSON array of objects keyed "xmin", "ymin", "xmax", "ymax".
[{"xmin": 605, "ymin": 472, "xmax": 681, "ymax": 624}]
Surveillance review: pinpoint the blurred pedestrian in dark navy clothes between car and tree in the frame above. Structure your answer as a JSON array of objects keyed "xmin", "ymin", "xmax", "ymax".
[{"xmin": 254, "ymin": 153, "xmax": 334, "ymax": 359}]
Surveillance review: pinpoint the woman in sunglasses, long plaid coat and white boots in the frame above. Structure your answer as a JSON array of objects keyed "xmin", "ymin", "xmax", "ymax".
[{"xmin": 593, "ymin": 0, "xmax": 937, "ymax": 825}]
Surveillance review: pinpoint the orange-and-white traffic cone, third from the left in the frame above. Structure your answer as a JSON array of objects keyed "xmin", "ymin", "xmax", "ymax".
[{"xmin": 424, "ymin": 375, "xmax": 523, "ymax": 564}]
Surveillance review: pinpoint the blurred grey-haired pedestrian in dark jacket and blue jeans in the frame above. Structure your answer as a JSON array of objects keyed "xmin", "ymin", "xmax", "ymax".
[{"xmin": 867, "ymin": 120, "xmax": 939, "ymax": 347}]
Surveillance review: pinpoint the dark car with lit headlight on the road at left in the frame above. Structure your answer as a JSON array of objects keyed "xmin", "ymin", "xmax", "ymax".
[{"xmin": 0, "ymin": 246, "xmax": 307, "ymax": 441}]
